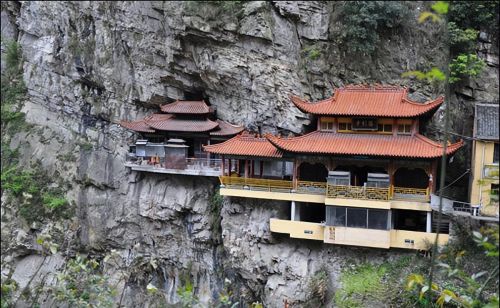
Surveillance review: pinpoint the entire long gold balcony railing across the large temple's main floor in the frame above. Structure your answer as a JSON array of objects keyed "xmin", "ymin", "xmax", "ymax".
[{"xmin": 219, "ymin": 176, "xmax": 430, "ymax": 202}]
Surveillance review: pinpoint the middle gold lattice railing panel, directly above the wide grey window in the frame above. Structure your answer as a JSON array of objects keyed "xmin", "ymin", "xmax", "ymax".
[{"xmin": 326, "ymin": 185, "xmax": 390, "ymax": 200}]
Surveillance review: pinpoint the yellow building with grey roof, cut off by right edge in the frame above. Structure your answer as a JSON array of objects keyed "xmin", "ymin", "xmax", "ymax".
[{"xmin": 470, "ymin": 104, "xmax": 500, "ymax": 217}]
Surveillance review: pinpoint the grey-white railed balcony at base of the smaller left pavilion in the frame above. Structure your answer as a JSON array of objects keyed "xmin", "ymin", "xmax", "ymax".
[{"xmin": 125, "ymin": 156, "xmax": 222, "ymax": 177}]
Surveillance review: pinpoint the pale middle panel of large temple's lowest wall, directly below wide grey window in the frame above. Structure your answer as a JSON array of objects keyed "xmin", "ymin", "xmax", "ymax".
[{"xmin": 325, "ymin": 227, "xmax": 391, "ymax": 248}]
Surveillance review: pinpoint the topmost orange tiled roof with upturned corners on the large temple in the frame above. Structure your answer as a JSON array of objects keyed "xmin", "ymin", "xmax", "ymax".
[{"xmin": 291, "ymin": 85, "xmax": 444, "ymax": 118}]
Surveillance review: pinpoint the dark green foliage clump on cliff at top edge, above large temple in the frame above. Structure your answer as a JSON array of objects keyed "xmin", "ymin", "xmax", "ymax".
[{"xmin": 341, "ymin": 1, "xmax": 409, "ymax": 54}]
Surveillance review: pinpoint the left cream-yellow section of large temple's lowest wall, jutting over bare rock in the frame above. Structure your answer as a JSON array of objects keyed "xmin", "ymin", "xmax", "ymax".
[{"xmin": 269, "ymin": 218, "xmax": 325, "ymax": 241}]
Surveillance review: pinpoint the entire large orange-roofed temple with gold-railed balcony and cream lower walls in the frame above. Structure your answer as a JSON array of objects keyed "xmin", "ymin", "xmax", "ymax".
[{"xmin": 204, "ymin": 86, "xmax": 463, "ymax": 250}]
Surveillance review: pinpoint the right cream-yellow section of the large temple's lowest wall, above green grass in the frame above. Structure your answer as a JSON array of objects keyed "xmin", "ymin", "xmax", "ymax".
[{"xmin": 391, "ymin": 230, "xmax": 449, "ymax": 250}]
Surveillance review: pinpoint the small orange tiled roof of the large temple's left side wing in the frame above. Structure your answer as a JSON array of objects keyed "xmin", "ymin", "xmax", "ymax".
[{"xmin": 203, "ymin": 133, "xmax": 283, "ymax": 158}]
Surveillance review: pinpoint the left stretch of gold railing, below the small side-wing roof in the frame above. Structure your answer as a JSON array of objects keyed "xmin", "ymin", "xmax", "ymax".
[{"xmin": 219, "ymin": 176, "xmax": 293, "ymax": 192}]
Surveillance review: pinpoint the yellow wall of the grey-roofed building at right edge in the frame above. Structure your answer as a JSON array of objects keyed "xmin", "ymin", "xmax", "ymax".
[{"xmin": 470, "ymin": 140, "xmax": 498, "ymax": 215}]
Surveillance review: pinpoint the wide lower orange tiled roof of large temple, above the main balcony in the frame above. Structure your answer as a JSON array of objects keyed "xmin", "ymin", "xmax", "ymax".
[{"xmin": 266, "ymin": 131, "xmax": 463, "ymax": 158}]
